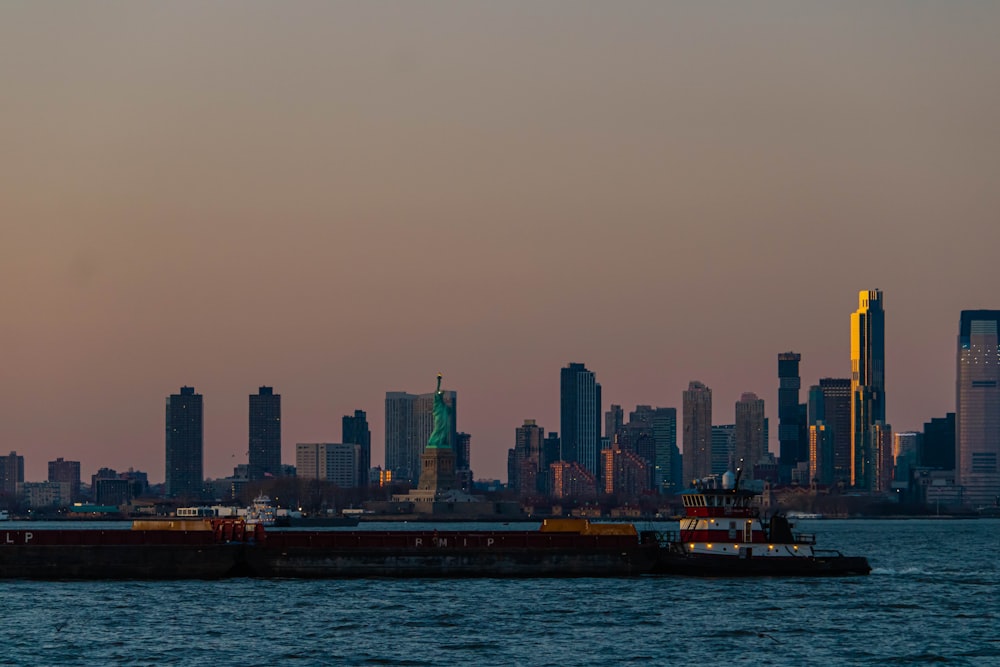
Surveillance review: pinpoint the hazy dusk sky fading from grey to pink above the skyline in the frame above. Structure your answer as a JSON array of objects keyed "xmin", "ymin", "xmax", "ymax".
[{"xmin": 0, "ymin": 0, "xmax": 1000, "ymax": 482}]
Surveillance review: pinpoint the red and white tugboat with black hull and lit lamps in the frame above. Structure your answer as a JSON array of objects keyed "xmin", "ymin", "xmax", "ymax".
[{"xmin": 655, "ymin": 470, "xmax": 871, "ymax": 577}]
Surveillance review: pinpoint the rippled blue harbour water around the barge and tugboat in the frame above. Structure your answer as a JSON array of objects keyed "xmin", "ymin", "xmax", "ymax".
[{"xmin": 0, "ymin": 519, "xmax": 1000, "ymax": 666}]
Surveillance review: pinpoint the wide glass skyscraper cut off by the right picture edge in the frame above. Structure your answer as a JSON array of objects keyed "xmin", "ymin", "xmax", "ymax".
[{"xmin": 955, "ymin": 310, "xmax": 1000, "ymax": 507}]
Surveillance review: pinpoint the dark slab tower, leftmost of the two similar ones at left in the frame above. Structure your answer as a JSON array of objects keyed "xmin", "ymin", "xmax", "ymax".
[{"xmin": 166, "ymin": 387, "xmax": 205, "ymax": 498}]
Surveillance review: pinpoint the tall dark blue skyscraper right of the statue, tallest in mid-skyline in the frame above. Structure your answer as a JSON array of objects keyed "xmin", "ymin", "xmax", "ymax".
[{"xmin": 559, "ymin": 363, "xmax": 601, "ymax": 477}]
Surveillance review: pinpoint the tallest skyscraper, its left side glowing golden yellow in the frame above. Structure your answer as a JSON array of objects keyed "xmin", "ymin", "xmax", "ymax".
[{"xmin": 851, "ymin": 289, "xmax": 885, "ymax": 491}]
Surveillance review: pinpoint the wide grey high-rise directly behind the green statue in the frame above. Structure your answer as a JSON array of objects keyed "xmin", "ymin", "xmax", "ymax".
[{"xmin": 385, "ymin": 391, "xmax": 458, "ymax": 485}]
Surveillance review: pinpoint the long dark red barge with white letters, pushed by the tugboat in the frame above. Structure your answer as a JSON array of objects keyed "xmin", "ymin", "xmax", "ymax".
[{"xmin": 0, "ymin": 518, "xmax": 658, "ymax": 579}]
